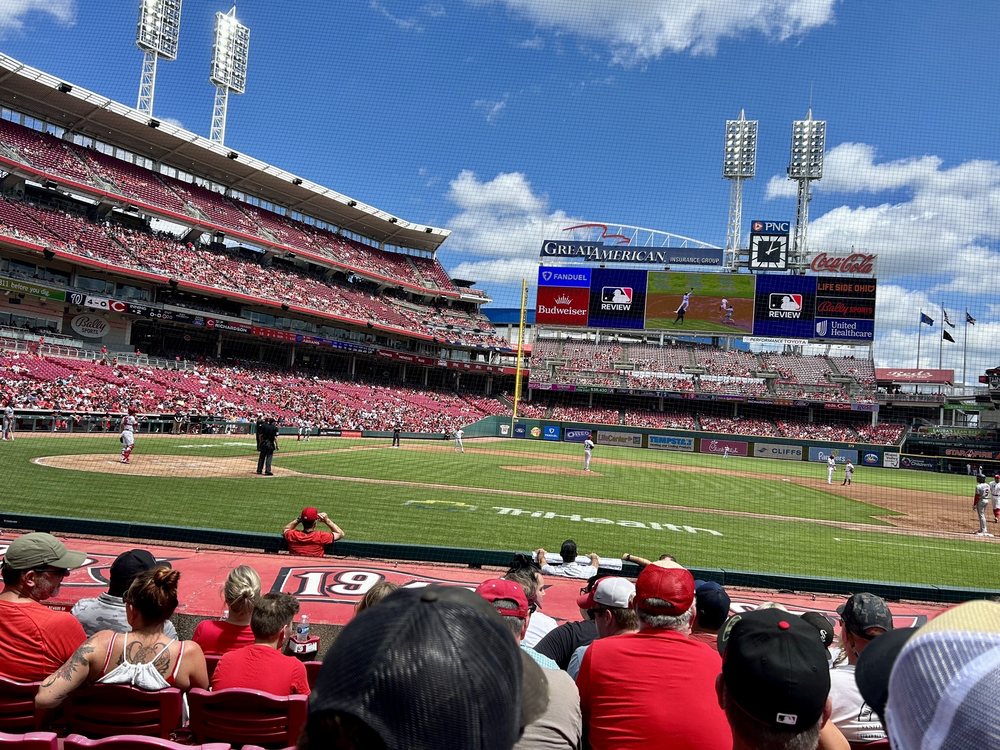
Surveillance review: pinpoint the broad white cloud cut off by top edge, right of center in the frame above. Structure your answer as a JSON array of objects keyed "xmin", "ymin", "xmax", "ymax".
[{"xmin": 470, "ymin": 0, "xmax": 836, "ymax": 65}]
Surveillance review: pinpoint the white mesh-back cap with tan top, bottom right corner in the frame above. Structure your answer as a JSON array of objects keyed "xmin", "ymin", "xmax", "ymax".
[{"xmin": 885, "ymin": 601, "xmax": 1000, "ymax": 750}]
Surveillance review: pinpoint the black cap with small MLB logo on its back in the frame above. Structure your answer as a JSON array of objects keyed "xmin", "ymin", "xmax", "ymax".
[{"xmin": 722, "ymin": 609, "xmax": 830, "ymax": 732}]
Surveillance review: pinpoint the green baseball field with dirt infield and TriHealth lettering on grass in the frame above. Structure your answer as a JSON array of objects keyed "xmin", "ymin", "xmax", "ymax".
[{"xmin": 0, "ymin": 434, "xmax": 1000, "ymax": 588}]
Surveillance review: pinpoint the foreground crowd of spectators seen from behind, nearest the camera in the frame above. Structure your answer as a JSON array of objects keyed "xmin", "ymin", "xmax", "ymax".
[{"xmin": 7, "ymin": 532, "xmax": 988, "ymax": 750}]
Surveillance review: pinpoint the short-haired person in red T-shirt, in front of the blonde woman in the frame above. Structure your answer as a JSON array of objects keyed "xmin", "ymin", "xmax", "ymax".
[{"xmin": 212, "ymin": 594, "xmax": 309, "ymax": 695}]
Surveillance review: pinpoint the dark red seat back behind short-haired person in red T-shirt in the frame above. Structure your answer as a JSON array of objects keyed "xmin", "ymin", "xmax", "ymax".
[{"xmin": 188, "ymin": 688, "xmax": 308, "ymax": 747}]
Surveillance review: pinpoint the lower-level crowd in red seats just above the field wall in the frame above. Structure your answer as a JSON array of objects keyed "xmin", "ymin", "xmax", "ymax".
[{"xmin": 0, "ymin": 349, "xmax": 904, "ymax": 445}]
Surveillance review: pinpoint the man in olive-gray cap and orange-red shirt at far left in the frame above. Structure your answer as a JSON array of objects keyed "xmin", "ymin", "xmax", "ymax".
[{"xmin": 0, "ymin": 532, "xmax": 87, "ymax": 682}]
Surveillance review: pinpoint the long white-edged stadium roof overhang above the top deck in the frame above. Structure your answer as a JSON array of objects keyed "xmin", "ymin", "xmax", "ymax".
[{"xmin": 0, "ymin": 53, "xmax": 450, "ymax": 252}]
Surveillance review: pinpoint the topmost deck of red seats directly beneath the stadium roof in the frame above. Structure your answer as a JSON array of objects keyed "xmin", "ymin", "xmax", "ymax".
[{"xmin": 0, "ymin": 120, "xmax": 457, "ymax": 294}]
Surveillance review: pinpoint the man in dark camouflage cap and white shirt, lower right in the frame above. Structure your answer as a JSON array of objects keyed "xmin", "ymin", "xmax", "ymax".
[{"xmin": 830, "ymin": 592, "xmax": 892, "ymax": 744}]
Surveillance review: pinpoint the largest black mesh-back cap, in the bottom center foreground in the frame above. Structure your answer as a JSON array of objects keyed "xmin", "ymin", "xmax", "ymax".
[{"xmin": 309, "ymin": 586, "xmax": 548, "ymax": 750}]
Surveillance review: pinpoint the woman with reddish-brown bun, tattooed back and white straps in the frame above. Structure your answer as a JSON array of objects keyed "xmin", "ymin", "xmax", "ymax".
[{"xmin": 35, "ymin": 567, "xmax": 208, "ymax": 709}]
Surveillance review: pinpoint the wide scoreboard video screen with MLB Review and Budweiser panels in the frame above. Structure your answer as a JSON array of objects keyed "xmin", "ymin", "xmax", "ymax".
[{"xmin": 535, "ymin": 266, "xmax": 877, "ymax": 344}]
